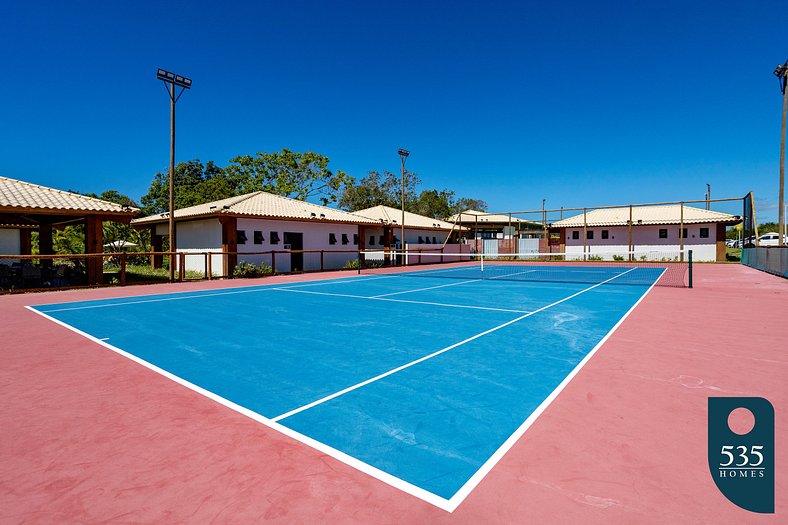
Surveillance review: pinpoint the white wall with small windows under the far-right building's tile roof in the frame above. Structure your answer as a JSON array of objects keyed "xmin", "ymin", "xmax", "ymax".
[{"xmin": 566, "ymin": 223, "xmax": 717, "ymax": 261}]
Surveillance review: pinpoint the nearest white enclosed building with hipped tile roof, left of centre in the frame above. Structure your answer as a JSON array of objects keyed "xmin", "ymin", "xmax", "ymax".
[{"xmin": 132, "ymin": 191, "xmax": 380, "ymax": 276}]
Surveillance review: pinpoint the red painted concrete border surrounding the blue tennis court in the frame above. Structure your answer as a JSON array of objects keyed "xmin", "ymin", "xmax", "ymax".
[{"xmin": 0, "ymin": 265, "xmax": 788, "ymax": 524}]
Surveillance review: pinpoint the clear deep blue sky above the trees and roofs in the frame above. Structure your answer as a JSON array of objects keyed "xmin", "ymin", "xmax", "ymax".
[{"xmin": 0, "ymin": 0, "xmax": 788, "ymax": 220}]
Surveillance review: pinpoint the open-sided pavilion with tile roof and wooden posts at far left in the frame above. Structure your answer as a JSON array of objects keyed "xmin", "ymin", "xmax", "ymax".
[{"xmin": 0, "ymin": 177, "xmax": 137, "ymax": 284}]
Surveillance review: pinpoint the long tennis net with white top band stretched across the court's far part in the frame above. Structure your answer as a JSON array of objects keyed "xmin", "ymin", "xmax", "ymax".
[{"xmin": 359, "ymin": 250, "xmax": 692, "ymax": 288}]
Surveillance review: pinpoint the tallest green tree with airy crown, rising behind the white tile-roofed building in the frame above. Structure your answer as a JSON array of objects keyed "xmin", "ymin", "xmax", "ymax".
[{"xmin": 225, "ymin": 148, "xmax": 353, "ymax": 205}]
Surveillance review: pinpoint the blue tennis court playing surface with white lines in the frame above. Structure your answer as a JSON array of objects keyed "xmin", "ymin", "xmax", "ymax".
[{"xmin": 27, "ymin": 267, "xmax": 661, "ymax": 508}]
